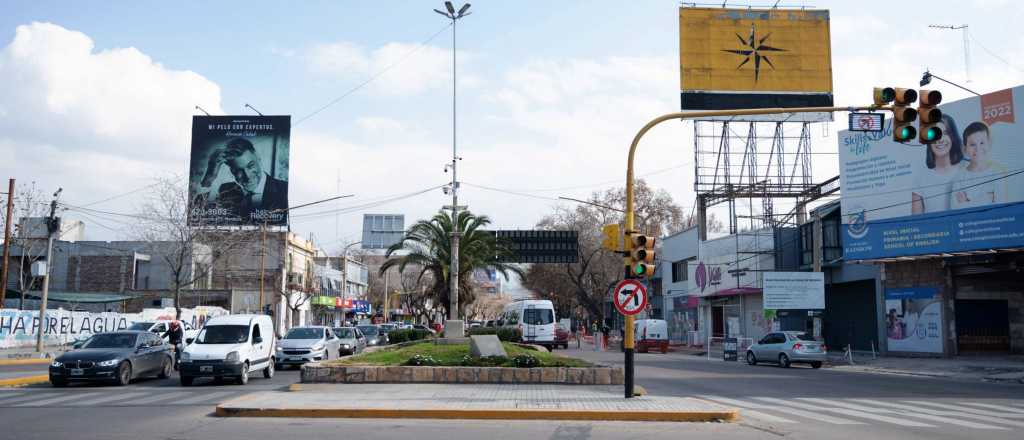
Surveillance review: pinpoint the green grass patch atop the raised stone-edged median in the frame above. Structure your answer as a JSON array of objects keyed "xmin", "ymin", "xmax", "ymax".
[{"xmin": 327, "ymin": 342, "xmax": 593, "ymax": 367}]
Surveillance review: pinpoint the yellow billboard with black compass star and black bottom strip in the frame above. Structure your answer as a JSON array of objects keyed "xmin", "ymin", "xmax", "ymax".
[{"xmin": 679, "ymin": 7, "xmax": 833, "ymax": 118}]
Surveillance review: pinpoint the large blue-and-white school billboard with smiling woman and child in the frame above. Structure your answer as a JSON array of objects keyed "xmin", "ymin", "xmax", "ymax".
[{"xmin": 839, "ymin": 86, "xmax": 1024, "ymax": 260}]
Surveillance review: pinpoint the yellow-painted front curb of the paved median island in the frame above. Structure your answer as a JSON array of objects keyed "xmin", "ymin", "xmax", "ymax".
[{"xmin": 215, "ymin": 405, "xmax": 739, "ymax": 422}]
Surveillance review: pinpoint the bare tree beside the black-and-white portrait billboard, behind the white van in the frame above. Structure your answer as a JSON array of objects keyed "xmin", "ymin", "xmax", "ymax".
[{"xmin": 131, "ymin": 176, "xmax": 252, "ymax": 319}]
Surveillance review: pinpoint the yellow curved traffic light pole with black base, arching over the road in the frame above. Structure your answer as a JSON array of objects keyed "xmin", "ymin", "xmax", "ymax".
[{"xmin": 623, "ymin": 105, "xmax": 891, "ymax": 399}]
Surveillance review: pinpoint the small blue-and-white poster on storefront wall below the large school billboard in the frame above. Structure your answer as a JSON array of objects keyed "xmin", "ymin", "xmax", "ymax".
[{"xmin": 886, "ymin": 288, "xmax": 942, "ymax": 353}]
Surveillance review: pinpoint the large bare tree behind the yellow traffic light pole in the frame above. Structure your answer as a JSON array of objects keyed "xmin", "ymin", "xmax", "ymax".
[{"xmin": 523, "ymin": 179, "xmax": 687, "ymax": 320}]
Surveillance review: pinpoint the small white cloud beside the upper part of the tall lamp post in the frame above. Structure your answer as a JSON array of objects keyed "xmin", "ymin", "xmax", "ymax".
[{"xmin": 305, "ymin": 41, "xmax": 482, "ymax": 96}]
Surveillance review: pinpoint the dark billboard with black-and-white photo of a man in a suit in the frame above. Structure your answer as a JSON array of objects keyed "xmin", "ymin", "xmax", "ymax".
[{"xmin": 188, "ymin": 116, "xmax": 292, "ymax": 226}]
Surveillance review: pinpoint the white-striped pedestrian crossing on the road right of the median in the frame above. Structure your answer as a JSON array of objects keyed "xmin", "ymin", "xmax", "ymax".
[{"xmin": 696, "ymin": 395, "xmax": 1024, "ymax": 431}]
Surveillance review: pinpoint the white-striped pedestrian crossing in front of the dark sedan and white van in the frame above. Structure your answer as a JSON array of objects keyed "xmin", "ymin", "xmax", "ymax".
[{"xmin": 0, "ymin": 390, "xmax": 245, "ymax": 408}]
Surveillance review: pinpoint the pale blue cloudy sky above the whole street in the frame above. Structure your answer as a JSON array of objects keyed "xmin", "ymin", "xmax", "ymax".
[{"xmin": 0, "ymin": 0, "xmax": 1024, "ymax": 260}]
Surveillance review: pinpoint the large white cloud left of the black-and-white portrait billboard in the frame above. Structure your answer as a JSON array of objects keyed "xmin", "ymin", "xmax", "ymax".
[{"xmin": 0, "ymin": 23, "xmax": 222, "ymax": 230}]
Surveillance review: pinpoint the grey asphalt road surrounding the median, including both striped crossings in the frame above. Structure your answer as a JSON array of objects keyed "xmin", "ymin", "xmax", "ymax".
[{"xmin": 0, "ymin": 350, "xmax": 1024, "ymax": 440}]
